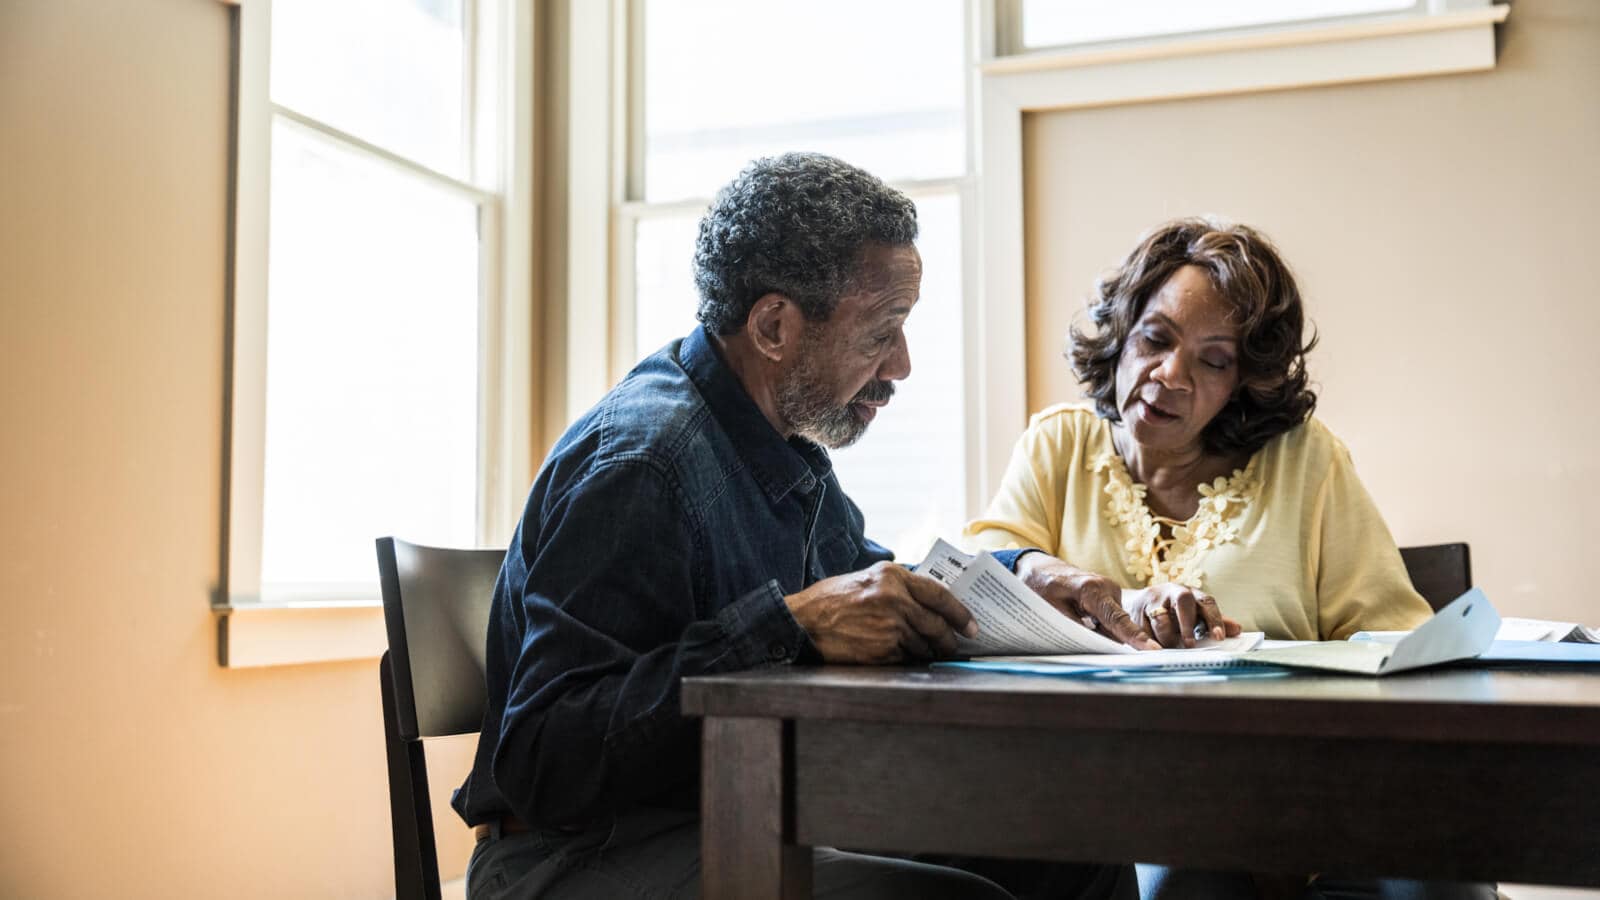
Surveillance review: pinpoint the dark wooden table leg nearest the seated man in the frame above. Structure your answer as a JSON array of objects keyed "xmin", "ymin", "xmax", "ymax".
[{"xmin": 701, "ymin": 716, "xmax": 811, "ymax": 900}]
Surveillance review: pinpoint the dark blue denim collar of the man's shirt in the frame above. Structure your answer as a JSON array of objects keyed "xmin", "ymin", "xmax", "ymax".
[{"xmin": 678, "ymin": 327, "xmax": 834, "ymax": 504}]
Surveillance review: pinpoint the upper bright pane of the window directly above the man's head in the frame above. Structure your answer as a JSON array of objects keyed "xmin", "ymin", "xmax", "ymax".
[{"xmin": 643, "ymin": 0, "xmax": 966, "ymax": 202}]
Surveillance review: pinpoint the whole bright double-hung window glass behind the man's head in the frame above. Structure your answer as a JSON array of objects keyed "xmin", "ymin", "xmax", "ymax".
[{"xmin": 613, "ymin": 0, "xmax": 973, "ymax": 559}]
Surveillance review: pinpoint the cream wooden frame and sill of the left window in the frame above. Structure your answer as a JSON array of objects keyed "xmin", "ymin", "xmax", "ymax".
[{"xmin": 213, "ymin": 0, "xmax": 534, "ymax": 668}]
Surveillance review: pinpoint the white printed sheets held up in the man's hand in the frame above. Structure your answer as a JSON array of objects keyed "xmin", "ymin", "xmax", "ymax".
[{"xmin": 917, "ymin": 540, "xmax": 1138, "ymax": 657}]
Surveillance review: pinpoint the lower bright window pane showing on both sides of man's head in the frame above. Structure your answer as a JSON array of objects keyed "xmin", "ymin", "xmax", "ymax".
[{"xmin": 635, "ymin": 194, "xmax": 966, "ymax": 562}]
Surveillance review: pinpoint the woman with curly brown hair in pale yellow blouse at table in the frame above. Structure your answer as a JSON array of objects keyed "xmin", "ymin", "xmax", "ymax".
[{"xmin": 968, "ymin": 219, "xmax": 1493, "ymax": 897}]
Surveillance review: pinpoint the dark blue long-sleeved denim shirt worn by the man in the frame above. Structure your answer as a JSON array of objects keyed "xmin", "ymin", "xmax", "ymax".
[{"xmin": 453, "ymin": 321, "xmax": 891, "ymax": 828}]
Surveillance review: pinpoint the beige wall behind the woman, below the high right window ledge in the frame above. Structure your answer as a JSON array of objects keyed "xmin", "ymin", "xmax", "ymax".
[{"xmin": 1024, "ymin": 0, "xmax": 1600, "ymax": 623}]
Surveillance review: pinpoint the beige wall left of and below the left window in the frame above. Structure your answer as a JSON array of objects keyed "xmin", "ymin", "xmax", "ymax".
[{"xmin": 0, "ymin": 0, "xmax": 469, "ymax": 898}]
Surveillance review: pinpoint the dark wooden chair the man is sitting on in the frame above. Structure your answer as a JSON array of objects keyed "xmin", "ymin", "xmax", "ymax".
[{"xmin": 378, "ymin": 538, "xmax": 506, "ymax": 900}]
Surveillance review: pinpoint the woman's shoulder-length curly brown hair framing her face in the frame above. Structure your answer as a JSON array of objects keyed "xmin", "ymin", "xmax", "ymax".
[{"xmin": 1067, "ymin": 218, "xmax": 1317, "ymax": 455}]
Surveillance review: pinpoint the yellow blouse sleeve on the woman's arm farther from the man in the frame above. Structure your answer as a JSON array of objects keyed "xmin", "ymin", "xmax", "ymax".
[{"xmin": 1315, "ymin": 440, "xmax": 1432, "ymax": 641}]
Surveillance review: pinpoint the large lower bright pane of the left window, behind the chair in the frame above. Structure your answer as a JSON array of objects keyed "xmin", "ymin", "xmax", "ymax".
[{"xmin": 261, "ymin": 120, "xmax": 478, "ymax": 593}]
